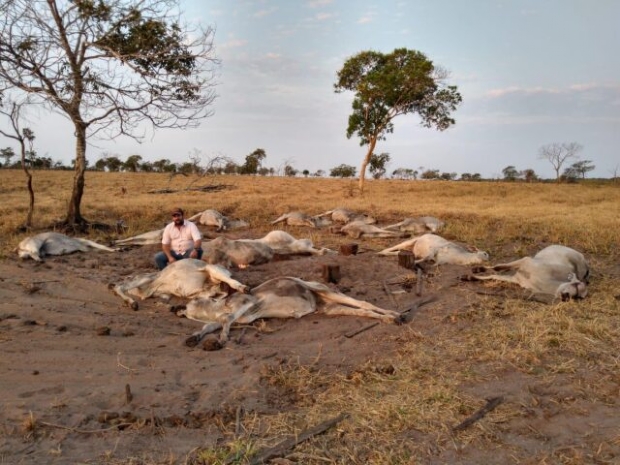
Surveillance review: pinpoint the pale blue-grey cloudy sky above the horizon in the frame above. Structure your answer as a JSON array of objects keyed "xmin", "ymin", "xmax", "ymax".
[{"xmin": 0, "ymin": 0, "xmax": 620, "ymax": 177}]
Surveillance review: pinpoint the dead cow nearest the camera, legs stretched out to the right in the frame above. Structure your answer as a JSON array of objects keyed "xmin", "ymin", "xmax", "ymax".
[{"xmin": 177, "ymin": 277, "xmax": 401, "ymax": 346}]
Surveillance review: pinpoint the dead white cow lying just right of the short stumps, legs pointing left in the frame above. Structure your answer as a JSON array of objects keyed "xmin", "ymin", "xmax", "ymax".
[{"xmin": 377, "ymin": 233, "xmax": 489, "ymax": 265}]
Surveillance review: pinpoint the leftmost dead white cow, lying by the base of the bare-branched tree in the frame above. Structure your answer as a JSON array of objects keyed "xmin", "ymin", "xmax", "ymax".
[{"xmin": 17, "ymin": 232, "xmax": 116, "ymax": 261}]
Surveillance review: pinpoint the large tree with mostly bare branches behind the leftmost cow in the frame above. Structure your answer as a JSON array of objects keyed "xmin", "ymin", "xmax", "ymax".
[{"xmin": 0, "ymin": 0, "xmax": 217, "ymax": 228}]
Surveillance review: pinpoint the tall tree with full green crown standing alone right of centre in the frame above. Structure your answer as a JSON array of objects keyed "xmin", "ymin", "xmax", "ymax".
[{"xmin": 334, "ymin": 48, "xmax": 462, "ymax": 190}]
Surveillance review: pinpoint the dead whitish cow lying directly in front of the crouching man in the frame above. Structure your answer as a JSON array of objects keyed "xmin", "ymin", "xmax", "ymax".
[{"xmin": 112, "ymin": 258, "xmax": 248, "ymax": 310}]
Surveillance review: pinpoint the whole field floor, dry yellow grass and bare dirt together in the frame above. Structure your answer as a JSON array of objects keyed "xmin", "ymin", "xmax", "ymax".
[{"xmin": 0, "ymin": 170, "xmax": 620, "ymax": 465}]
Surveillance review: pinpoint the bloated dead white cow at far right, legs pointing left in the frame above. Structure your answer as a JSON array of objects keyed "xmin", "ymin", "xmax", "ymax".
[{"xmin": 474, "ymin": 245, "xmax": 590, "ymax": 301}]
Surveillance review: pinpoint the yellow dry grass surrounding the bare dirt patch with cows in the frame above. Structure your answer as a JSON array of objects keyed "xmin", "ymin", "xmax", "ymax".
[{"xmin": 0, "ymin": 170, "xmax": 620, "ymax": 465}]
